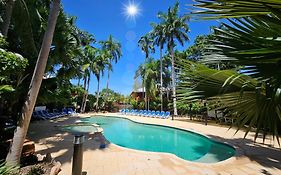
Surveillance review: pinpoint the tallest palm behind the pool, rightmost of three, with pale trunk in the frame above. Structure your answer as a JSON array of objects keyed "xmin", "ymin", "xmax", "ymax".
[{"xmin": 158, "ymin": 2, "xmax": 189, "ymax": 120}]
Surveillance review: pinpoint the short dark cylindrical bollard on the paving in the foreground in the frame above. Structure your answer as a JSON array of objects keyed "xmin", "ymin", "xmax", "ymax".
[{"xmin": 72, "ymin": 135, "xmax": 85, "ymax": 175}]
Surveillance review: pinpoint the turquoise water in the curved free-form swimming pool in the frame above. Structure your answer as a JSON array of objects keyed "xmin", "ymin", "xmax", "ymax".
[{"xmin": 80, "ymin": 117, "xmax": 235, "ymax": 163}]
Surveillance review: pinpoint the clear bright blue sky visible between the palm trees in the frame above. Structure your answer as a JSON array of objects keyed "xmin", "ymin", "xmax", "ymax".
[{"xmin": 62, "ymin": 0, "xmax": 218, "ymax": 95}]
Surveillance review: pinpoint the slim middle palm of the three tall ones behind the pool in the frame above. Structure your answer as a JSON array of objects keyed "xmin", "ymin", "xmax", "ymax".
[{"xmin": 151, "ymin": 23, "xmax": 166, "ymax": 111}]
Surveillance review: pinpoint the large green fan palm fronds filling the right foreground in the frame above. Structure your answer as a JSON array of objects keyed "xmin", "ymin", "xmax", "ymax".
[{"xmin": 177, "ymin": 0, "xmax": 281, "ymax": 141}]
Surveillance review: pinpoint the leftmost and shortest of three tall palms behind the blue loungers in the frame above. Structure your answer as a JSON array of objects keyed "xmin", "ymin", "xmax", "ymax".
[{"xmin": 138, "ymin": 33, "xmax": 155, "ymax": 109}]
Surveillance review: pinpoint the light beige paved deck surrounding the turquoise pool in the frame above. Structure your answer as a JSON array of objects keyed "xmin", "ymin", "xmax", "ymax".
[{"xmin": 28, "ymin": 113, "xmax": 281, "ymax": 175}]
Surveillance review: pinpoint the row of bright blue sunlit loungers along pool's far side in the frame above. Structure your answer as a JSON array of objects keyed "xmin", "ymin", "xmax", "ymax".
[{"xmin": 120, "ymin": 109, "xmax": 171, "ymax": 119}]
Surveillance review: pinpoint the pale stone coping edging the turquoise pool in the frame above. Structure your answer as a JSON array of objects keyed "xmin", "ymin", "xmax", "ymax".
[{"xmin": 81, "ymin": 114, "xmax": 241, "ymax": 166}]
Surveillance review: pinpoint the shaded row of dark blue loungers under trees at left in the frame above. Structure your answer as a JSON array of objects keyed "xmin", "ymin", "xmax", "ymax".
[{"xmin": 32, "ymin": 108, "xmax": 75, "ymax": 120}]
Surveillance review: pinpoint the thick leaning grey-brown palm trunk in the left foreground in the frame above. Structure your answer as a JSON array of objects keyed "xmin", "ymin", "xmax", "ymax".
[{"xmin": 6, "ymin": 0, "xmax": 60, "ymax": 165}]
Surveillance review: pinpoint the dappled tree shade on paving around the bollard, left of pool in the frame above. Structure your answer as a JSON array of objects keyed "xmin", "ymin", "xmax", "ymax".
[{"xmin": 28, "ymin": 116, "xmax": 108, "ymax": 164}]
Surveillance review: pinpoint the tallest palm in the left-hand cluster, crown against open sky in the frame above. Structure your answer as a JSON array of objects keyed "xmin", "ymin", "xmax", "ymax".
[{"xmin": 100, "ymin": 35, "xmax": 122, "ymax": 96}]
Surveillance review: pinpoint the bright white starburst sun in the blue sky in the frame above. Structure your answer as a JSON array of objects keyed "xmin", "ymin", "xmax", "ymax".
[{"xmin": 123, "ymin": 1, "xmax": 141, "ymax": 21}]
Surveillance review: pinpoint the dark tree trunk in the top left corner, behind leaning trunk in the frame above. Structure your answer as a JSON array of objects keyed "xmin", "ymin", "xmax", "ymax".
[{"xmin": 1, "ymin": 0, "xmax": 16, "ymax": 37}]
